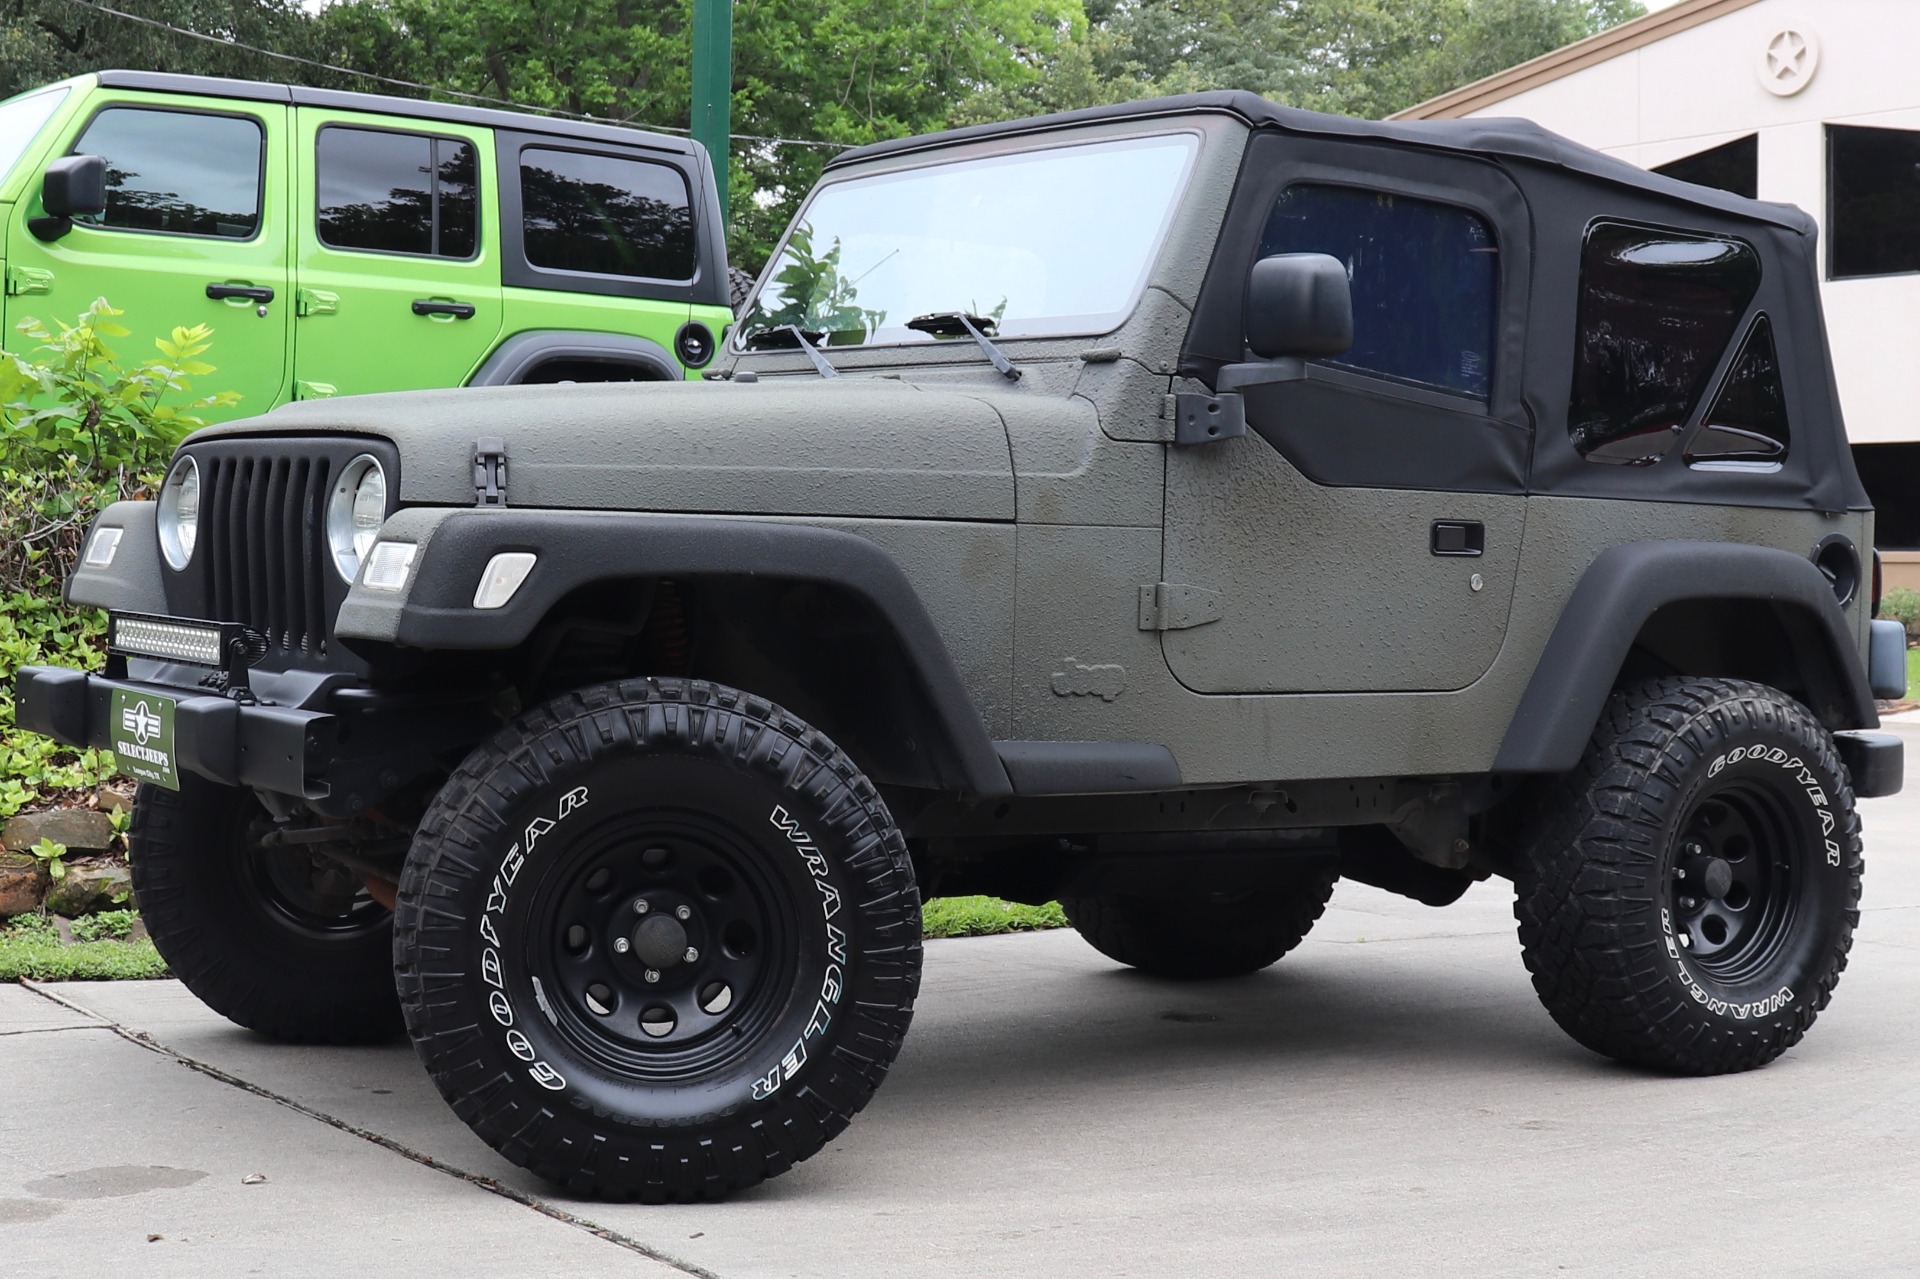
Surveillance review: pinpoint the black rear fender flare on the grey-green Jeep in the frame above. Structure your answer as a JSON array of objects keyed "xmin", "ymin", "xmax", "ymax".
[{"xmin": 1494, "ymin": 542, "xmax": 1880, "ymax": 772}]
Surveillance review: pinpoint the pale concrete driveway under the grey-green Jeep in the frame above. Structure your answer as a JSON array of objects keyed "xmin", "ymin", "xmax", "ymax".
[{"xmin": 0, "ymin": 724, "xmax": 1920, "ymax": 1279}]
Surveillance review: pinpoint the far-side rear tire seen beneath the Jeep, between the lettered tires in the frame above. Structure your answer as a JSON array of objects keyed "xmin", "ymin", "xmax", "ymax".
[{"xmin": 1060, "ymin": 858, "xmax": 1340, "ymax": 979}]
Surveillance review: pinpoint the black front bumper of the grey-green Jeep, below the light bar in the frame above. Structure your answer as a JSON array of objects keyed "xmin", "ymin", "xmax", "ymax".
[{"xmin": 13, "ymin": 666, "xmax": 338, "ymax": 801}]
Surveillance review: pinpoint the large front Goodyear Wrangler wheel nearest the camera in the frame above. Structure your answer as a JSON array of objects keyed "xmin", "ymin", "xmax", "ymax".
[{"xmin": 394, "ymin": 680, "xmax": 920, "ymax": 1202}]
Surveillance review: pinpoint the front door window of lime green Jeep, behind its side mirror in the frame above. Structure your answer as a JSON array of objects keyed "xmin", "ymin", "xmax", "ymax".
[{"xmin": 73, "ymin": 108, "xmax": 265, "ymax": 240}]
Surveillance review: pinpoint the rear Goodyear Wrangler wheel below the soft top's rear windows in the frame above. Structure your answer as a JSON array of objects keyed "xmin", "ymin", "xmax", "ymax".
[{"xmin": 1515, "ymin": 678, "xmax": 1862, "ymax": 1075}]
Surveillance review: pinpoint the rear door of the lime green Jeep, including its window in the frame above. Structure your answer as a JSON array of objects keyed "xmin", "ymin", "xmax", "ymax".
[{"xmin": 294, "ymin": 108, "xmax": 501, "ymax": 399}]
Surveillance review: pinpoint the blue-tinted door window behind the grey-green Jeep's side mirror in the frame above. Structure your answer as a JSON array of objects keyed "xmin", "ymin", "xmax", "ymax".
[{"xmin": 1260, "ymin": 186, "xmax": 1500, "ymax": 399}]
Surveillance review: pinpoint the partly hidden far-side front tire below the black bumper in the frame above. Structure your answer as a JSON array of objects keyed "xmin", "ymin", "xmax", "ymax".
[{"xmin": 129, "ymin": 774, "xmax": 401, "ymax": 1045}]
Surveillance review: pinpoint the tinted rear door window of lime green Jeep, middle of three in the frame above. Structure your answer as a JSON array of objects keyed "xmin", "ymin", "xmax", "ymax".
[{"xmin": 315, "ymin": 127, "xmax": 478, "ymax": 257}]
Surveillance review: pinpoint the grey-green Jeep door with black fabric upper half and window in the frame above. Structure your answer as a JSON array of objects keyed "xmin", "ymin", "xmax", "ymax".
[{"xmin": 1162, "ymin": 136, "xmax": 1528, "ymax": 693}]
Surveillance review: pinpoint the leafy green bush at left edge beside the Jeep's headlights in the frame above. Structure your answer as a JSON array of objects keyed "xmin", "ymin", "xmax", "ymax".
[{"xmin": 0, "ymin": 298, "xmax": 240, "ymax": 818}]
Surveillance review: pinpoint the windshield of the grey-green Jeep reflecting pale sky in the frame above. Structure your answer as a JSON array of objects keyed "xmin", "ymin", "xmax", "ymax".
[{"xmin": 741, "ymin": 134, "xmax": 1198, "ymax": 346}]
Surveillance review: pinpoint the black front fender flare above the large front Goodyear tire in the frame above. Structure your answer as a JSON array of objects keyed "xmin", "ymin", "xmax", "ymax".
[{"xmin": 334, "ymin": 507, "xmax": 1014, "ymax": 795}]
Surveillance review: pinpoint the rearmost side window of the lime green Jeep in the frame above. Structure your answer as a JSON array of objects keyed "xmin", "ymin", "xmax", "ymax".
[{"xmin": 520, "ymin": 148, "xmax": 693, "ymax": 280}]
